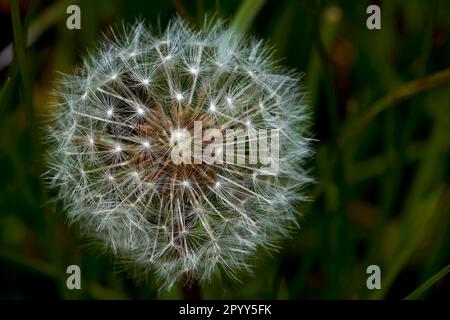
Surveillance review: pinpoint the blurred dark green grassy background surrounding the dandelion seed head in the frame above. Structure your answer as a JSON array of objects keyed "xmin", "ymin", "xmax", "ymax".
[{"xmin": 0, "ymin": 0, "xmax": 450, "ymax": 299}]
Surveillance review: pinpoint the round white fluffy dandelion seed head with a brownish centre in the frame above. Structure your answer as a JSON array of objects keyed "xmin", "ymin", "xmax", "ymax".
[{"xmin": 49, "ymin": 19, "xmax": 310, "ymax": 287}]
